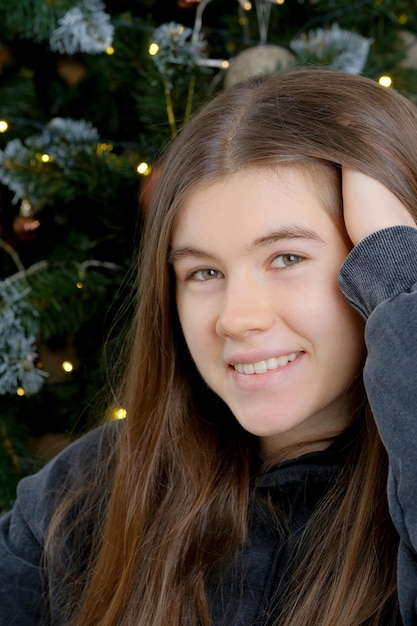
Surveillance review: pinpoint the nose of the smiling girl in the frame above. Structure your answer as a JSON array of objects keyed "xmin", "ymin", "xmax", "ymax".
[{"xmin": 216, "ymin": 280, "xmax": 275, "ymax": 338}]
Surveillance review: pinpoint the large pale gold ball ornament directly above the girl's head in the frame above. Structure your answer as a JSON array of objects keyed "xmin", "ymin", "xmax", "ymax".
[{"xmin": 224, "ymin": 44, "xmax": 295, "ymax": 89}]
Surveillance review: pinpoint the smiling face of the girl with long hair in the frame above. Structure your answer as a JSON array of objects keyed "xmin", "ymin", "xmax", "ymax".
[{"xmin": 171, "ymin": 168, "xmax": 365, "ymax": 454}]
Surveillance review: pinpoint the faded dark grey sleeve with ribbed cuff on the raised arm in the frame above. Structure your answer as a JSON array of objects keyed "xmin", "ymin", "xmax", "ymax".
[{"xmin": 339, "ymin": 226, "xmax": 417, "ymax": 626}]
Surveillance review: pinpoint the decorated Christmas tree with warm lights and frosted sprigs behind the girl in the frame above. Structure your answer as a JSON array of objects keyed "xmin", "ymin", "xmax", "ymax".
[{"xmin": 0, "ymin": 0, "xmax": 417, "ymax": 508}]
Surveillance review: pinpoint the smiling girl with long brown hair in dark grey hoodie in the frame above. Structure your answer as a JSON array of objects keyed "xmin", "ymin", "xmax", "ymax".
[{"xmin": 0, "ymin": 69, "xmax": 417, "ymax": 626}]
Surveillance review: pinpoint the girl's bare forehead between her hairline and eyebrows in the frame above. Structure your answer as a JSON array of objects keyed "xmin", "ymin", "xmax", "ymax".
[{"xmin": 172, "ymin": 166, "xmax": 339, "ymax": 246}]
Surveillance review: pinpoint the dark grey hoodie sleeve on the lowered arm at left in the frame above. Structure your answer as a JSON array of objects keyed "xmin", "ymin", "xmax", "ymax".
[{"xmin": 0, "ymin": 427, "xmax": 115, "ymax": 626}]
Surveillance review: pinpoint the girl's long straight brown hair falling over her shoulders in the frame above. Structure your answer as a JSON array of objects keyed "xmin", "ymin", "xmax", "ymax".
[{"xmin": 47, "ymin": 68, "xmax": 417, "ymax": 626}]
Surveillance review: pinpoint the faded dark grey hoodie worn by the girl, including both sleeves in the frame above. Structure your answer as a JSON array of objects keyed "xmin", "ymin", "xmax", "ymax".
[{"xmin": 0, "ymin": 227, "xmax": 417, "ymax": 626}]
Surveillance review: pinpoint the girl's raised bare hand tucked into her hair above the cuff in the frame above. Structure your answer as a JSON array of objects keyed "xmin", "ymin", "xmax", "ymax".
[{"xmin": 342, "ymin": 167, "xmax": 417, "ymax": 245}]
